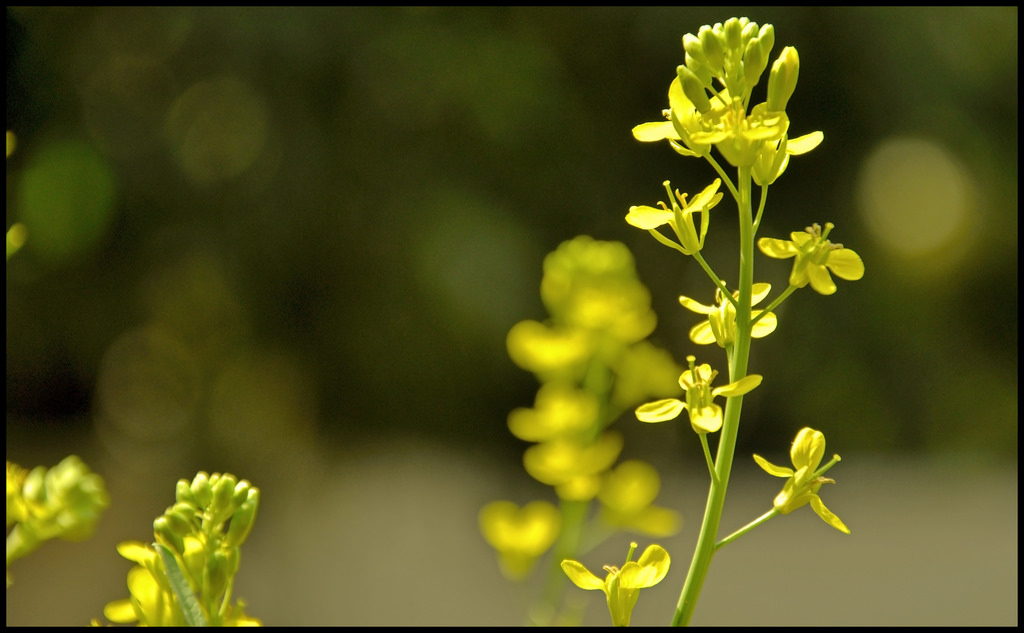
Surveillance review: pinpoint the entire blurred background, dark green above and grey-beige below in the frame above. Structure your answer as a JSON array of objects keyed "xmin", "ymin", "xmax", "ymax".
[{"xmin": 6, "ymin": 7, "xmax": 1018, "ymax": 625}]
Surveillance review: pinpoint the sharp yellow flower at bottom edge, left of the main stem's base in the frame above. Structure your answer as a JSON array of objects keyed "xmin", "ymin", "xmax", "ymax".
[{"xmin": 562, "ymin": 543, "xmax": 671, "ymax": 627}]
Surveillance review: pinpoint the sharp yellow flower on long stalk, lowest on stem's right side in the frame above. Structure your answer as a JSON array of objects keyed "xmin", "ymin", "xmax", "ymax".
[{"xmin": 754, "ymin": 427, "xmax": 850, "ymax": 534}]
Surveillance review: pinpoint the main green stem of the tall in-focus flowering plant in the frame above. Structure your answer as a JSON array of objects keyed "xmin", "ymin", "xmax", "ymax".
[{"xmin": 672, "ymin": 167, "xmax": 754, "ymax": 626}]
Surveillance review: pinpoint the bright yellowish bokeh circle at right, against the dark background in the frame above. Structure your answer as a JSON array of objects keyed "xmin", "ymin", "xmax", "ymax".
[{"xmin": 858, "ymin": 138, "xmax": 978, "ymax": 270}]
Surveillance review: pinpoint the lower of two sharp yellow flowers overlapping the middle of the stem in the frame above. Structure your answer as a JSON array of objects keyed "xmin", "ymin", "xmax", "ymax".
[{"xmin": 636, "ymin": 355, "xmax": 761, "ymax": 434}]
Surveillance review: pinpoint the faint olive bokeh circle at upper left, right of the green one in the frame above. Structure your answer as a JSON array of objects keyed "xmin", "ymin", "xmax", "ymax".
[{"xmin": 167, "ymin": 77, "xmax": 267, "ymax": 183}]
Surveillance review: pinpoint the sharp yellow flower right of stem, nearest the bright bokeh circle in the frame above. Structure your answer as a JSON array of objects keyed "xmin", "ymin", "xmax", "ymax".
[{"xmin": 758, "ymin": 222, "xmax": 864, "ymax": 295}]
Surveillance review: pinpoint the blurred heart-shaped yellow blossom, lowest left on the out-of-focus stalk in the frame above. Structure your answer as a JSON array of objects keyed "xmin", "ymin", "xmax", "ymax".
[{"xmin": 479, "ymin": 501, "xmax": 562, "ymax": 580}]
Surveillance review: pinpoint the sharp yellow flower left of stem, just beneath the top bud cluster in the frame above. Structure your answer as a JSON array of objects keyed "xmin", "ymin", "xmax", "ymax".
[{"xmin": 626, "ymin": 178, "xmax": 722, "ymax": 255}]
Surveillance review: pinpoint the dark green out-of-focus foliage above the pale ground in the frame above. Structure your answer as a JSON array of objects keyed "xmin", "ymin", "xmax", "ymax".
[{"xmin": 7, "ymin": 7, "xmax": 1018, "ymax": 473}]
